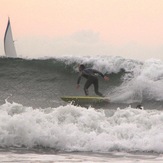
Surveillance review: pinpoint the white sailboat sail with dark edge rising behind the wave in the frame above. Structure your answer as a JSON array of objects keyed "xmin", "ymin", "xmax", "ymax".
[{"xmin": 4, "ymin": 18, "xmax": 17, "ymax": 58}]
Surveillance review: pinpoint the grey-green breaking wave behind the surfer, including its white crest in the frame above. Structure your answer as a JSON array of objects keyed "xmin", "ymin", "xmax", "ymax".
[{"xmin": 0, "ymin": 56, "xmax": 163, "ymax": 108}]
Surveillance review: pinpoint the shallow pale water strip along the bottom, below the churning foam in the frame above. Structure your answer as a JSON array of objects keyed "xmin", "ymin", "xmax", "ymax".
[{"xmin": 0, "ymin": 149, "xmax": 163, "ymax": 163}]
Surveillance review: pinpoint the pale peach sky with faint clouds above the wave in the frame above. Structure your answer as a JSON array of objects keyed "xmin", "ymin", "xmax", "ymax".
[{"xmin": 0, "ymin": 0, "xmax": 163, "ymax": 60}]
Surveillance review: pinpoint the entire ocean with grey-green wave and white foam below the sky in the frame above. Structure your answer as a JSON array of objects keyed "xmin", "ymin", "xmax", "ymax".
[{"xmin": 0, "ymin": 56, "xmax": 163, "ymax": 163}]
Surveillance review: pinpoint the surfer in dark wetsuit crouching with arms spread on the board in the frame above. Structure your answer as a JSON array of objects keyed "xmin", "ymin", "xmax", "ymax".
[{"xmin": 77, "ymin": 64, "xmax": 109, "ymax": 97}]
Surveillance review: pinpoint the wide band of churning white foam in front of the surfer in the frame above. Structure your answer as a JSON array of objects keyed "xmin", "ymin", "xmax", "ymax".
[{"xmin": 0, "ymin": 102, "xmax": 163, "ymax": 153}]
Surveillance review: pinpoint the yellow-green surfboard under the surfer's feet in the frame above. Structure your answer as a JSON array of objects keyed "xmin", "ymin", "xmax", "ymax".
[{"xmin": 61, "ymin": 96, "xmax": 109, "ymax": 105}]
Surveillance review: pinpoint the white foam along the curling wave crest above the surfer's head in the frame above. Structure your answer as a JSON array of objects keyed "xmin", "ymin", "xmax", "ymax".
[{"xmin": 57, "ymin": 56, "xmax": 142, "ymax": 73}]
